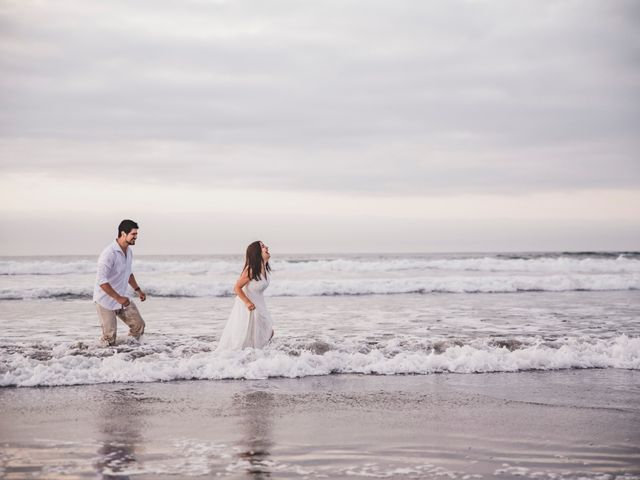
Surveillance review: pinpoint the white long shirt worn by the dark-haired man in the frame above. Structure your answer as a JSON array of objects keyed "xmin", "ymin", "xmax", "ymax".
[{"xmin": 93, "ymin": 240, "xmax": 133, "ymax": 310}]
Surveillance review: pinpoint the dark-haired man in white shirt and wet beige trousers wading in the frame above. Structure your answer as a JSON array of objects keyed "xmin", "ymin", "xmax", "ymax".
[{"xmin": 93, "ymin": 220, "xmax": 147, "ymax": 345}]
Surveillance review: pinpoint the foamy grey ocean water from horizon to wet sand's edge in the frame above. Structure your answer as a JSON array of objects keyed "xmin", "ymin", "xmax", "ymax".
[{"xmin": 0, "ymin": 252, "xmax": 640, "ymax": 387}]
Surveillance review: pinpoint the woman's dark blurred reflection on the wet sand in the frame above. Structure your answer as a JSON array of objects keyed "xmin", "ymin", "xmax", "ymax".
[{"xmin": 234, "ymin": 390, "xmax": 273, "ymax": 479}]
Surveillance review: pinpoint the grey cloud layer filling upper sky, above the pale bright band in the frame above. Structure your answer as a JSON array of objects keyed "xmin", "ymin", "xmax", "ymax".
[{"xmin": 0, "ymin": 0, "xmax": 640, "ymax": 195}]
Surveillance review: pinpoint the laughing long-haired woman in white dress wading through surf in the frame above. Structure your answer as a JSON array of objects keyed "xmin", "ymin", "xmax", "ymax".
[{"xmin": 216, "ymin": 242, "xmax": 273, "ymax": 350}]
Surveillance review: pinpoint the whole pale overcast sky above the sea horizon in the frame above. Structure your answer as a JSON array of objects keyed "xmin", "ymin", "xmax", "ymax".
[{"xmin": 0, "ymin": 0, "xmax": 640, "ymax": 255}]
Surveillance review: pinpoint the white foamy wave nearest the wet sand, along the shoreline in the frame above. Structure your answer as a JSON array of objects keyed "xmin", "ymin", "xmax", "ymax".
[{"xmin": 0, "ymin": 335, "xmax": 640, "ymax": 387}]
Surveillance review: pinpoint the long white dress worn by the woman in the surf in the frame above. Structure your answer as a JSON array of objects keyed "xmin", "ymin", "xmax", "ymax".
[{"xmin": 216, "ymin": 277, "xmax": 273, "ymax": 350}]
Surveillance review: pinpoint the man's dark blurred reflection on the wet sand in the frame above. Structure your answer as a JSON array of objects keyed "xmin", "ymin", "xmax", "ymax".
[{"xmin": 95, "ymin": 387, "xmax": 144, "ymax": 480}]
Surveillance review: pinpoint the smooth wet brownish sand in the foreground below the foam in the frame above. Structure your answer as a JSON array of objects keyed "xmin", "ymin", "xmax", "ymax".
[{"xmin": 0, "ymin": 369, "xmax": 640, "ymax": 480}]
